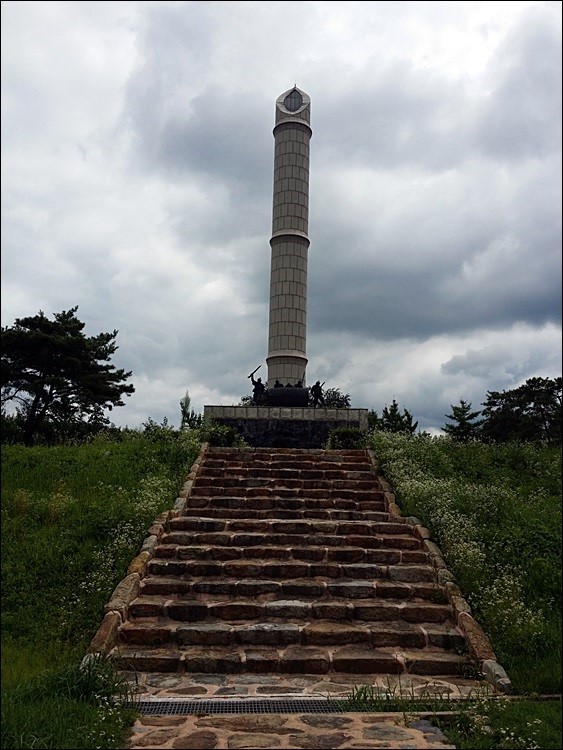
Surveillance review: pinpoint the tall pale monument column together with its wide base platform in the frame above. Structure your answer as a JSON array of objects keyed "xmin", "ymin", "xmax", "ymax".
[{"xmin": 203, "ymin": 91, "xmax": 368, "ymax": 449}]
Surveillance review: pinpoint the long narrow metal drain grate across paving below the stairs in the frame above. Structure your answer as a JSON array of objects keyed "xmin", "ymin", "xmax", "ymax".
[{"xmin": 136, "ymin": 698, "xmax": 344, "ymax": 716}]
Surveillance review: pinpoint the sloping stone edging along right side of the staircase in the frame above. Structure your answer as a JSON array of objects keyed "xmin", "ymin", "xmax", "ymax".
[{"xmin": 366, "ymin": 448, "xmax": 512, "ymax": 693}]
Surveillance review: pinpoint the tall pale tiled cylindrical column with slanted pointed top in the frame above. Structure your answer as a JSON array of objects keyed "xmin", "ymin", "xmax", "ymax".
[{"xmin": 266, "ymin": 86, "xmax": 313, "ymax": 388}]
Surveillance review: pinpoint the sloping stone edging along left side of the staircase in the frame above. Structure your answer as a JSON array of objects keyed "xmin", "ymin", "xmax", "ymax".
[{"xmin": 86, "ymin": 443, "xmax": 209, "ymax": 664}]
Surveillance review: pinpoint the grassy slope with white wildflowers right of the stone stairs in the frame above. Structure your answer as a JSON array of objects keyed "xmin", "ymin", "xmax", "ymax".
[{"xmin": 374, "ymin": 433, "xmax": 561, "ymax": 693}]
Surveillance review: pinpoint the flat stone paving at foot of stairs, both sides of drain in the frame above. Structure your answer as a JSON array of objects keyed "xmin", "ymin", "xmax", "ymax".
[{"xmin": 123, "ymin": 673, "xmax": 485, "ymax": 750}]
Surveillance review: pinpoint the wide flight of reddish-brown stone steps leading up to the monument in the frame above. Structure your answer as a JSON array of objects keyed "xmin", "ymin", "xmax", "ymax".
[{"xmin": 107, "ymin": 448, "xmax": 471, "ymax": 682}]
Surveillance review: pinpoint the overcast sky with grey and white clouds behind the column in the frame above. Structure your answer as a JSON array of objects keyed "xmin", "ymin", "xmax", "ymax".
[{"xmin": 1, "ymin": 0, "xmax": 562, "ymax": 431}]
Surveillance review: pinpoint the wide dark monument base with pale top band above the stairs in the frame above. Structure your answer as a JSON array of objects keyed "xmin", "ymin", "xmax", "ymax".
[{"xmin": 203, "ymin": 406, "xmax": 368, "ymax": 448}]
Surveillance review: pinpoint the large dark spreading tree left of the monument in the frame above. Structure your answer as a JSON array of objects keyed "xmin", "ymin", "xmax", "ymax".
[{"xmin": 0, "ymin": 306, "xmax": 135, "ymax": 445}]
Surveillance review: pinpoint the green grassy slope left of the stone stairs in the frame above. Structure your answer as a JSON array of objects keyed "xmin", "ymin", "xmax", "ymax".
[{"xmin": 1, "ymin": 429, "xmax": 201, "ymax": 748}]
